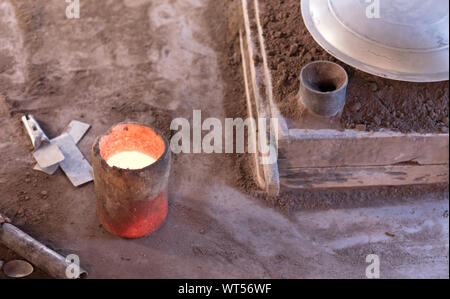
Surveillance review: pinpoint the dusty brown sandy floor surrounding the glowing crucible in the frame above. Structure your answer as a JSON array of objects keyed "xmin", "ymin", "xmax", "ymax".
[{"xmin": 0, "ymin": 0, "xmax": 449, "ymax": 278}]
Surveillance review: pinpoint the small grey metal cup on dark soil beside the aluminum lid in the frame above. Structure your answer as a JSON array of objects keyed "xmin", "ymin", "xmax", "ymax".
[{"xmin": 300, "ymin": 61, "xmax": 348, "ymax": 117}]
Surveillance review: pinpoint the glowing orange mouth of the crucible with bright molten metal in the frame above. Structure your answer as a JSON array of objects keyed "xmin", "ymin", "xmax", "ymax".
[{"xmin": 99, "ymin": 124, "xmax": 165, "ymax": 170}]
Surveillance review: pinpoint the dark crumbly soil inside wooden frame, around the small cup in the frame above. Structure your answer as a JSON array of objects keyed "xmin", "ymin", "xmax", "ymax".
[{"xmin": 260, "ymin": 0, "xmax": 449, "ymax": 133}]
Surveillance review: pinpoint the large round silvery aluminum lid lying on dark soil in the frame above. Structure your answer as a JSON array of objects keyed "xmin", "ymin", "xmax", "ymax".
[{"xmin": 302, "ymin": 0, "xmax": 449, "ymax": 82}]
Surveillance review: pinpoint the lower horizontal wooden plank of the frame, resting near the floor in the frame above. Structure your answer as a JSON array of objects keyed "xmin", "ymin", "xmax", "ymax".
[{"xmin": 280, "ymin": 164, "xmax": 449, "ymax": 189}]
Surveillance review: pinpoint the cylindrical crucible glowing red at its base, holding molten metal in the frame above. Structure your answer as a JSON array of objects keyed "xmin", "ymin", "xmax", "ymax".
[{"xmin": 92, "ymin": 123, "xmax": 170, "ymax": 239}]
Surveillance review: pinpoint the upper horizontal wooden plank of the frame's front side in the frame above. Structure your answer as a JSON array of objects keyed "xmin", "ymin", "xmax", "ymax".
[{"xmin": 279, "ymin": 130, "xmax": 449, "ymax": 168}]
